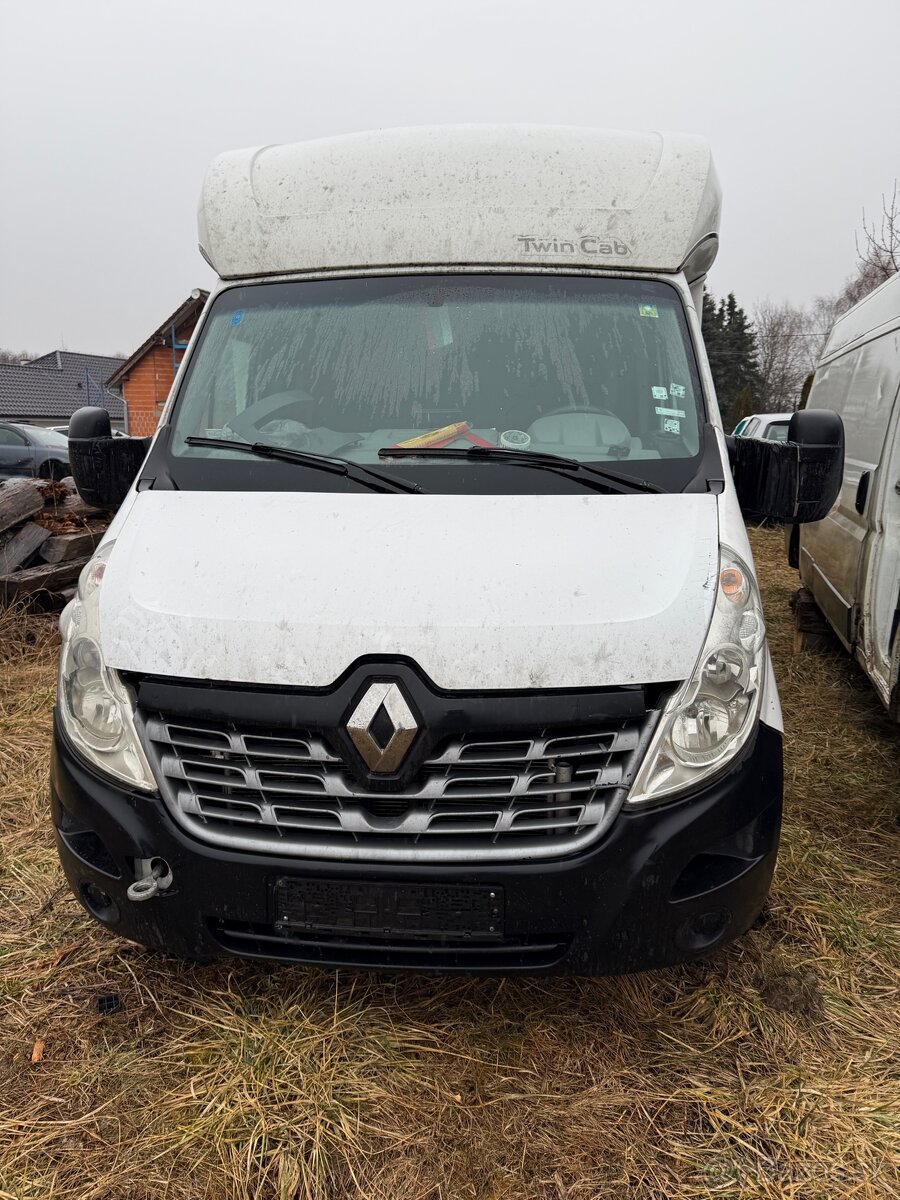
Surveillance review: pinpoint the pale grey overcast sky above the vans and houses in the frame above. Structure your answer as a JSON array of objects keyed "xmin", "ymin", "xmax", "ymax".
[{"xmin": 0, "ymin": 0, "xmax": 900, "ymax": 353}]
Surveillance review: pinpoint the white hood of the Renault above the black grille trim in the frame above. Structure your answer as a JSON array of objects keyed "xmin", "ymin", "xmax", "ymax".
[{"xmin": 101, "ymin": 491, "xmax": 719, "ymax": 690}]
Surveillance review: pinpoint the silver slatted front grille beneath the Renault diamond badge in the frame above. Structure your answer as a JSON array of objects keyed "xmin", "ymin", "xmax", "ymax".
[{"xmin": 142, "ymin": 713, "xmax": 649, "ymax": 862}]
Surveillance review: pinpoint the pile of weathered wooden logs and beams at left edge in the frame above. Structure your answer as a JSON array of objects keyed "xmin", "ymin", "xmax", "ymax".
[{"xmin": 0, "ymin": 478, "xmax": 112, "ymax": 608}]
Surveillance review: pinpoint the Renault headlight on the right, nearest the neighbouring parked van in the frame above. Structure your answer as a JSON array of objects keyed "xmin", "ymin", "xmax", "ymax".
[{"xmin": 628, "ymin": 546, "xmax": 766, "ymax": 805}]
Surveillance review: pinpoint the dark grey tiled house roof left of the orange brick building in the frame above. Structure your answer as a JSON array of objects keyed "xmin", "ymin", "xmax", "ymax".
[{"xmin": 0, "ymin": 350, "xmax": 125, "ymax": 424}]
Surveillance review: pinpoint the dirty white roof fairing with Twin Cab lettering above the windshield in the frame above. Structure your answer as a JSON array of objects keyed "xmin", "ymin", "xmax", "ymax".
[{"xmin": 198, "ymin": 125, "xmax": 720, "ymax": 278}]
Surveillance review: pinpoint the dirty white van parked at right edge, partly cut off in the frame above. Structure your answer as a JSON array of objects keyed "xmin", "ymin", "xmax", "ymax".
[{"xmin": 788, "ymin": 275, "xmax": 900, "ymax": 720}]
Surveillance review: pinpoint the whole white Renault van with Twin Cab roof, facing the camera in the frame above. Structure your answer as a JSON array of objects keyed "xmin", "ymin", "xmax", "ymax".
[{"xmin": 52, "ymin": 126, "xmax": 841, "ymax": 973}]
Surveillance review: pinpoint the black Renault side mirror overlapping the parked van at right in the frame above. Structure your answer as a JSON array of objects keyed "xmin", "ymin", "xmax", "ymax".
[{"xmin": 726, "ymin": 408, "xmax": 844, "ymax": 524}]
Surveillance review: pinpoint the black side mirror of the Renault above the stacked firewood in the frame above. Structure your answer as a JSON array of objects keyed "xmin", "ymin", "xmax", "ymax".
[{"xmin": 68, "ymin": 408, "xmax": 150, "ymax": 509}]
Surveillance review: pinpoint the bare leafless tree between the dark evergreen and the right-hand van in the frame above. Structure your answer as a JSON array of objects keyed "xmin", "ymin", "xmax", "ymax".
[{"xmin": 754, "ymin": 300, "xmax": 818, "ymax": 413}]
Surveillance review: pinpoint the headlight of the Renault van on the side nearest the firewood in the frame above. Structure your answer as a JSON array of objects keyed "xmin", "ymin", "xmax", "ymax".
[{"xmin": 58, "ymin": 541, "xmax": 156, "ymax": 791}]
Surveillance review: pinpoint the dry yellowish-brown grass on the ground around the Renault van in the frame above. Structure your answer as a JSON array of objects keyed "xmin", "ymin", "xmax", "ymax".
[{"xmin": 0, "ymin": 530, "xmax": 900, "ymax": 1200}]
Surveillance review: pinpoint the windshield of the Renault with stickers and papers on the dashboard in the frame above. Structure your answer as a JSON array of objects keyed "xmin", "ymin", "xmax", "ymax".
[{"xmin": 169, "ymin": 275, "xmax": 703, "ymax": 491}]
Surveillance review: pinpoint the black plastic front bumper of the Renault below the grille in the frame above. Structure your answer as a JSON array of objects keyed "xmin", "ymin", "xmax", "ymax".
[{"xmin": 50, "ymin": 710, "xmax": 782, "ymax": 974}]
